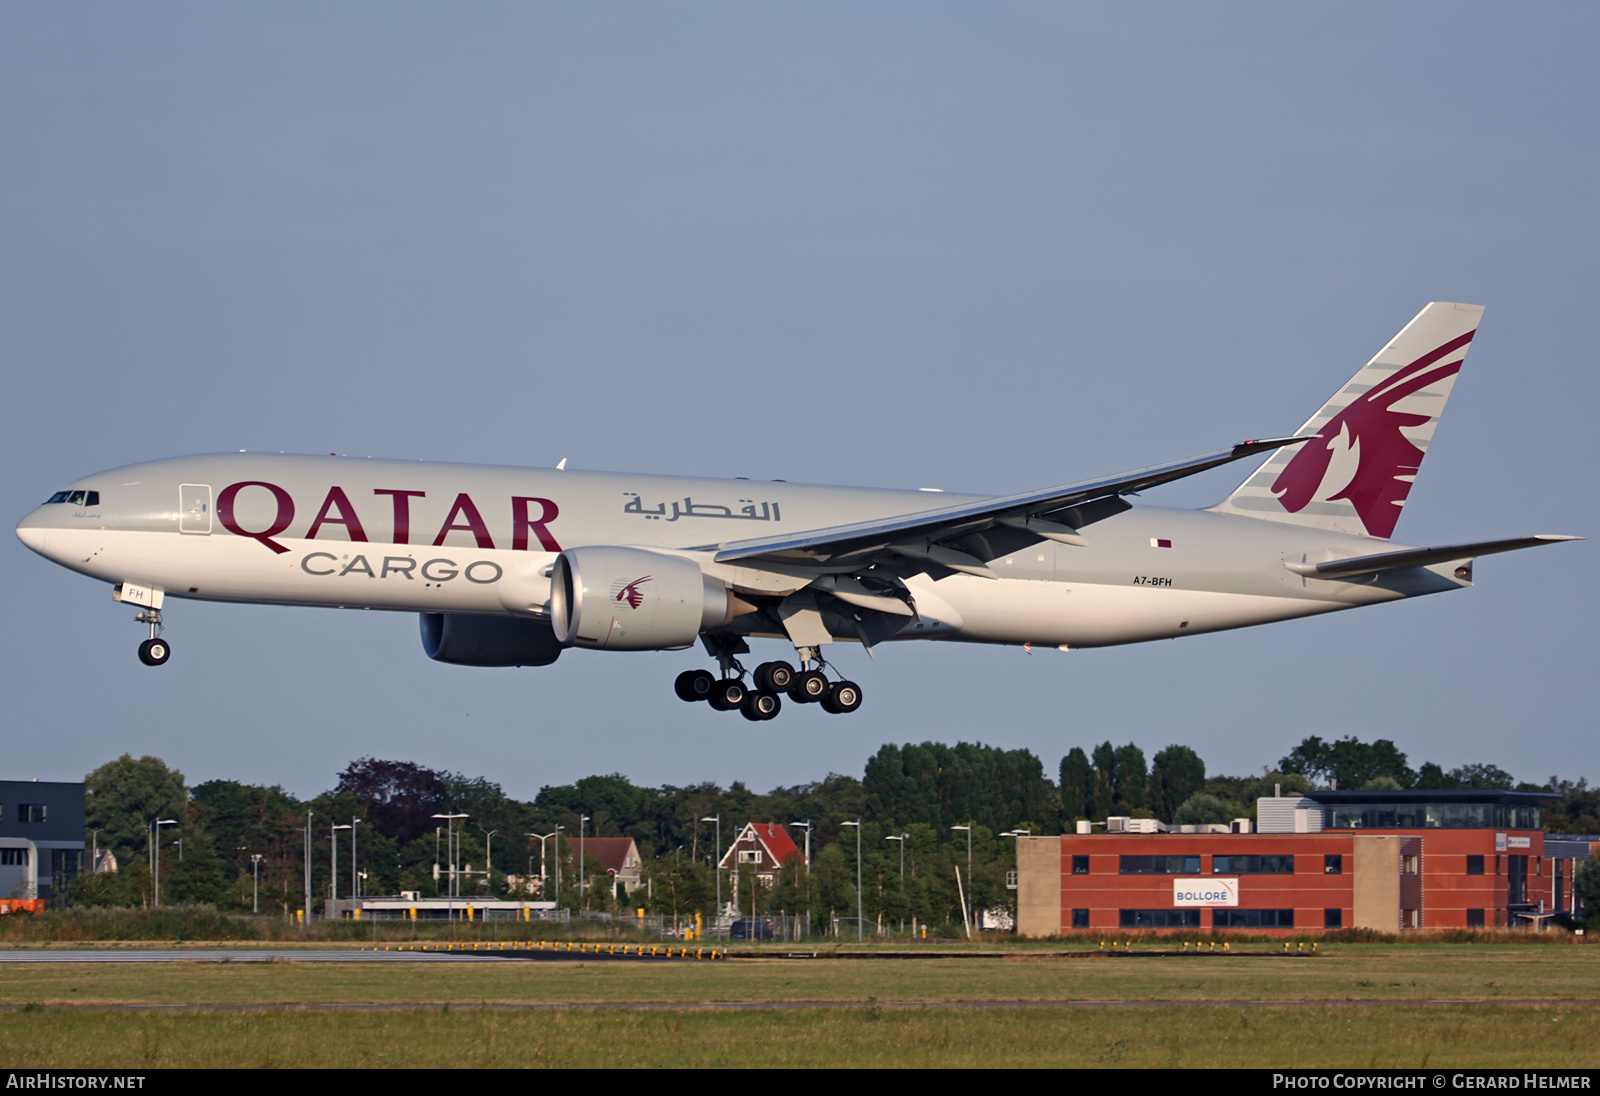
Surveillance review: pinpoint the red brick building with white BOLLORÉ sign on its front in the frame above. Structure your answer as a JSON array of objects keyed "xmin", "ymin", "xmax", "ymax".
[{"xmin": 1018, "ymin": 792, "xmax": 1570, "ymax": 936}]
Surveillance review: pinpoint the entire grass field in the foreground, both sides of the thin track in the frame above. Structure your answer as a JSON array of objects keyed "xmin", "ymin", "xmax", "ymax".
[{"xmin": 0, "ymin": 944, "xmax": 1600, "ymax": 1069}]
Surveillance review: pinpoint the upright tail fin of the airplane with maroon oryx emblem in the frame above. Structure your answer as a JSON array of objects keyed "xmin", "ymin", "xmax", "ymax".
[{"xmin": 1211, "ymin": 301, "xmax": 1483, "ymax": 539}]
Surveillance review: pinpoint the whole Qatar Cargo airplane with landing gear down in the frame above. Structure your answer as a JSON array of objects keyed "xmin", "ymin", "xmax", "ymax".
[{"xmin": 16, "ymin": 302, "xmax": 1579, "ymax": 720}]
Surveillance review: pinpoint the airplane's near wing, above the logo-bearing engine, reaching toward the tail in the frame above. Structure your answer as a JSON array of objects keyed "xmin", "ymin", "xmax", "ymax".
[{"xmin": 715, "ymin": 437, "xmax": 1309, "ymax": 578}]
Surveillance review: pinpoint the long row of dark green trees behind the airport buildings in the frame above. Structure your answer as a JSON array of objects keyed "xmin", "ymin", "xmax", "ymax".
[{"xmin": 72, "ymin": 736, "xmax": 1600, "ymax": 926}]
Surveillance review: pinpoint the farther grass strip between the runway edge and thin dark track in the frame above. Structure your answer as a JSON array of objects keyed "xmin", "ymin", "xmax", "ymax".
[{"xmin": 0, "ymin": 946, "xmax": 1600, "ymax": 1005}]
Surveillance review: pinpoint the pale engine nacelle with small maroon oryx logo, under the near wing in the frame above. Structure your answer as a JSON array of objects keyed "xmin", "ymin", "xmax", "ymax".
[{"xmin": 550, "ymin": 546, "xmax": 739, "ymax": 651}]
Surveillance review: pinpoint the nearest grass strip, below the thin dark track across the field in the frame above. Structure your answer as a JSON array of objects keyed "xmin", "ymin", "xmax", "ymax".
[{"xmin": 0, "ymin": 1005, "xmax": 1600, "ymax": 1069}]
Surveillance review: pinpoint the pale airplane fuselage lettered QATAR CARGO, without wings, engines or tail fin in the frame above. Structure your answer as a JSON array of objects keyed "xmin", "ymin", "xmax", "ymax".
[{"xmin": 18, "ymin": 453, "xmax": 1470, "ymax": 648}]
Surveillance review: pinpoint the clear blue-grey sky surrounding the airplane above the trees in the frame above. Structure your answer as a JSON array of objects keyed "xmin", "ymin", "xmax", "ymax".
[{"xmin": 0, "ymin": 3, "xmax": 1600, "ymax": 797}]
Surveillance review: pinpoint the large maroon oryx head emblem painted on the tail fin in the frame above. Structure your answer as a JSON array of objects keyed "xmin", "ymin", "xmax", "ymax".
[{"xmin": 1272, "ymin": 331, "xmax": 1474, "ymax": 538}]
